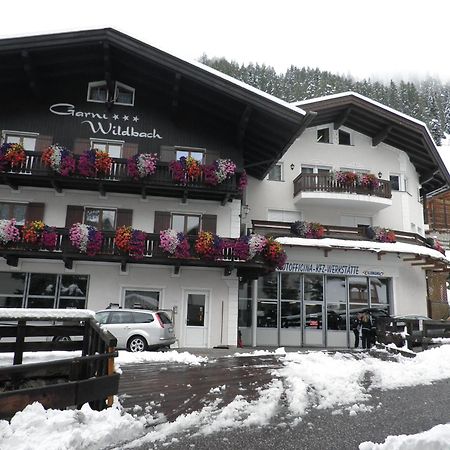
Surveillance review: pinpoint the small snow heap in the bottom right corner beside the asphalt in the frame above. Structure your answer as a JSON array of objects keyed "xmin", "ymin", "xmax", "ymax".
[{"xmin": 359, "ymin": 423, "xmax": 450, "ymax": 450}]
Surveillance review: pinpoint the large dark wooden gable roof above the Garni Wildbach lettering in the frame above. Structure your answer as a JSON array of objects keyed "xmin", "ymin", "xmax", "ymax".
[{"xmin": 0, "ymin": 28, "xmax": 310, "ymax": 178}]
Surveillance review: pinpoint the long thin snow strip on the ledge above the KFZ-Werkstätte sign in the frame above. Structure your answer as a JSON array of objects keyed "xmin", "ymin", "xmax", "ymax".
[{"xmin": 276, "ymin": 237, "xmax": 450, "ymax": 264}]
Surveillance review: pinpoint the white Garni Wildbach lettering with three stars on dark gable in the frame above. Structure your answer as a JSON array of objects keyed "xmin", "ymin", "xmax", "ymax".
[{"xmin": 49, "ymin": 103, "xmax": 162, "ymax": 139}]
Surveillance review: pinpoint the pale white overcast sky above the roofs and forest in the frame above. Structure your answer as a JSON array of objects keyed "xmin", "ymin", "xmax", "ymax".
[{"xmin": 0, "ymin": 0, "xmax": 450, "ymax": 80}]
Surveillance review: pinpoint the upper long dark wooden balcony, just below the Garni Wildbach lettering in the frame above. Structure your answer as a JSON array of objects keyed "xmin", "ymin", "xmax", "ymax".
[{"xmin": 0, "ymin": 152, "xmax": 242, "ymax": 205}]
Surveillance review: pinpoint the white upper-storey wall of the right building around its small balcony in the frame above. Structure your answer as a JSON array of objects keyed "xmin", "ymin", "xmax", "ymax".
[{"xmin": 246, "ymin": 125, "xmax": 424, "ymax": 234}]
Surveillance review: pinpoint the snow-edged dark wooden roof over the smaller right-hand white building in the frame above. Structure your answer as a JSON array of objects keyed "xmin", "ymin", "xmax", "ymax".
[{"xmin": 294, "ymin": 92, "xmax": 450, "ymax": 192}]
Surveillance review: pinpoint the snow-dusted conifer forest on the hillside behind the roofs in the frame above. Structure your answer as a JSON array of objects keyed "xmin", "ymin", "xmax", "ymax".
[{"xmin": 200, "ymin": 55, "xmax": 450, "ymax": 145}]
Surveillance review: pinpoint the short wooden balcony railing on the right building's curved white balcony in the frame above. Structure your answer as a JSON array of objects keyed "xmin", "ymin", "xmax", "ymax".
[{"xmin": 294, "ymin": 173, "xmax": 392, "ymax": 198}]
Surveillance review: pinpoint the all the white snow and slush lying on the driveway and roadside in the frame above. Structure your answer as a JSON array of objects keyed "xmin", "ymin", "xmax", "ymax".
[{"xmin": 0, "ymin": 345, "xmax": 450, "ymax": 450}]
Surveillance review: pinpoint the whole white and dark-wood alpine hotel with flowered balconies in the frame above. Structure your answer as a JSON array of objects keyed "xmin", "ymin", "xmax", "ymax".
[{"xmin": 0, "ymin": 29, "xmax": 449, "ymax": 347}]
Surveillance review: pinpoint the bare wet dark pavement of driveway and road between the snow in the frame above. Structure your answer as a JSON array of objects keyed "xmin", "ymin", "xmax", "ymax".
[{"xmin": 120, "ymin": 356, "xmax": 450, "ymax": 450}]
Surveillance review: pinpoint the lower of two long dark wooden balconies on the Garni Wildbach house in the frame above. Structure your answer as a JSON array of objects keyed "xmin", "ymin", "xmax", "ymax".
[{"xmin": 0, "ymin": 227, "xmax": 270, "ymax": 277}]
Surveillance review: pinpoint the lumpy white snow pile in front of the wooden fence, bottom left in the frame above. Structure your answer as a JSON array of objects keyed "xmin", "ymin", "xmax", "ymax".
[{"xmin": 0, "ymin": 402, "xmax": 146, "ymax": 450}]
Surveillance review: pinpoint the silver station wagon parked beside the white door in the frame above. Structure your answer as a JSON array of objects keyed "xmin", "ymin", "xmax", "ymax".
[{"xmin": 95, "ymin": 309, "xmax": 176, "ymax": 352}]
